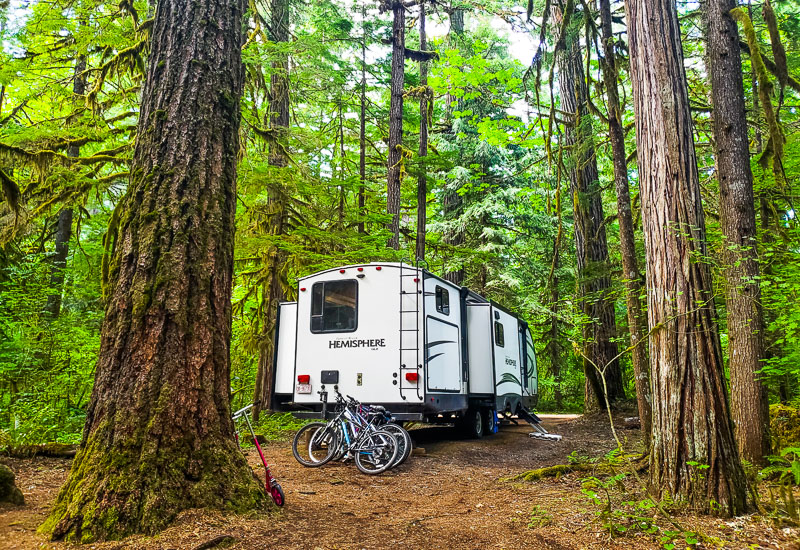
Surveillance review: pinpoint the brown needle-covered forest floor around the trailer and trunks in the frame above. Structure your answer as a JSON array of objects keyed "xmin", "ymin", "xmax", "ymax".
[{"xmin": 0, "ymin": 415, "xmax": 800, "ymax": 550}]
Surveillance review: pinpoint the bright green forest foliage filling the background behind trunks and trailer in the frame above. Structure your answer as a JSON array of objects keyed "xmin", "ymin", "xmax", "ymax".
[{"xmin": 0, "ymin": 0, "xmax": 800, "ymax": 452}]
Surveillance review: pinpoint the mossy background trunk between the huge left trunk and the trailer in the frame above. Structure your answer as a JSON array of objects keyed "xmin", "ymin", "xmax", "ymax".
[{"xmin": 253, "ymin": 0, "xmax": 289, "ymax": 420}]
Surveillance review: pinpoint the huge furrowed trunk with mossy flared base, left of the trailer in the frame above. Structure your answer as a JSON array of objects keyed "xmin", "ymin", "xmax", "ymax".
[{"xmin": 43, "ymin": 0, "xmax": 265, "ymax": 542}]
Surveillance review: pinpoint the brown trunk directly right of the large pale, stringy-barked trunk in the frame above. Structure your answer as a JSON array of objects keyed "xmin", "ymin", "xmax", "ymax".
[{"xmin": 703, "ymin": 0, "xmax": 770, "ymax": 464}]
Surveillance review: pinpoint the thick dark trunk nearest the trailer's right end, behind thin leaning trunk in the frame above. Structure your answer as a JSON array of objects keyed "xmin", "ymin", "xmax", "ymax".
[{"xmin": 557, "ymin": 10, "xmax": 625, "ymax": 413}]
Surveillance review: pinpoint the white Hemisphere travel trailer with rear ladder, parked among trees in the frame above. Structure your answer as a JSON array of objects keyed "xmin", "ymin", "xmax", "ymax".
[{"xmin": 273, "ymin": 263, "xmax": 546, "ymax": 437}]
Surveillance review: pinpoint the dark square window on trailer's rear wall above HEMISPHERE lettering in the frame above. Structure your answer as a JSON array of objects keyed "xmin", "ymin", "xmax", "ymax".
[{"xmin": 311, "ymin": 280, "xmax": 358, "ymax": 333}]
